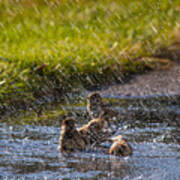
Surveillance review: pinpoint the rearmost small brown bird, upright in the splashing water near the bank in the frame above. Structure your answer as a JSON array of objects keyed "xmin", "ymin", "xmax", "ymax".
[{"xmin": 87, "ymin": 92, "xmax": 118, "ymax": 131}]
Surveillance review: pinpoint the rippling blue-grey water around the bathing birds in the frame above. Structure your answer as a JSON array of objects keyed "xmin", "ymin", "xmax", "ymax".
[{"xmin": 0, "ymin": 95, "xmax": 180, "ymax": 180}]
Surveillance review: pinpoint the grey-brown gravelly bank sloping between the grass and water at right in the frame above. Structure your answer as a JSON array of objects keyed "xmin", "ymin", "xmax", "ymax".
[{"xmin": 100, "ymin": 63, "xmax": 180, "ymax": 96}]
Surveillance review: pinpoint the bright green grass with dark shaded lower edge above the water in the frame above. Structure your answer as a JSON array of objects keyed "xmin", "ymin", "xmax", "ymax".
[{"xmin": 0, "ymin": 0, "xmax": 180, "ymax": 114}]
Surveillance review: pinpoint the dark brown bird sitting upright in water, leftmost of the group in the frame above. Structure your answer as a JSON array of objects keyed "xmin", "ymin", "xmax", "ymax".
[{"xmin": 59, "ymin": 118, "xmax": 86, "ymax": 153}]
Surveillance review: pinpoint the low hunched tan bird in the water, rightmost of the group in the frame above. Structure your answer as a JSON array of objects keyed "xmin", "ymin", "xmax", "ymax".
[{"xmin": 109, "ymin": 135, "xmax": 133, "ymax": 156}]
